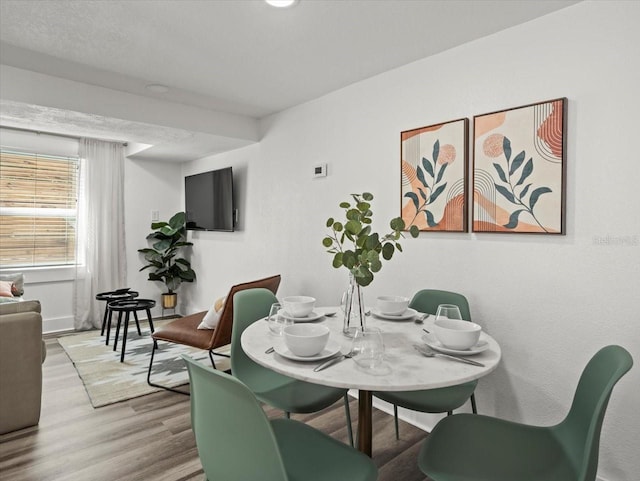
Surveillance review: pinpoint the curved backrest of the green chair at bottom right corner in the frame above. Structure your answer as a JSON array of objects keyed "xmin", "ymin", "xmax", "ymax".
[{"xmin": 553, "ymin": 346, "xmax": 633, "ymax": 481}]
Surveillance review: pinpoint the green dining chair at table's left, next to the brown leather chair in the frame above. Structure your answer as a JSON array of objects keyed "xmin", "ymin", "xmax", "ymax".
[{"xmin": 231, "ymin": 289, "xmax": 353, "ymax": 446}]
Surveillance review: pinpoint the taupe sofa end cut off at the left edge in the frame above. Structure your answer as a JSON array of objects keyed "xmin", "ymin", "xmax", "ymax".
[{"xmin": 0, "ymin": 301, "xmax": 46, "ymax": 434}]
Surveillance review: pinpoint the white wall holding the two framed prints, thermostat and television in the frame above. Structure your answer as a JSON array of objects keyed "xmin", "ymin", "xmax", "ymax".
[{"xmin": 184, "ymin": 2, "xmax": 640, "ymax": 481}]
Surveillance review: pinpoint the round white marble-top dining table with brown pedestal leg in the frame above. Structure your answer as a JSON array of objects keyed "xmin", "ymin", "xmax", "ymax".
[{"xmin": 241, "ymin": 307, "xmax": 502, "ymax": 456}]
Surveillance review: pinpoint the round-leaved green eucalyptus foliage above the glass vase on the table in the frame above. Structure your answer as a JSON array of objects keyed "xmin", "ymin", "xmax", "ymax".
[{"xmin": 322, "ymin": 192, "xmax": 419, "ymax": 287}]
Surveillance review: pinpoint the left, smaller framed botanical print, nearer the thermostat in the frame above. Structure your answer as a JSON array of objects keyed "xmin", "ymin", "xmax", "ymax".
[{"xmin": 400, "ymin": 119, "xmax": 469, "ymax": 232}]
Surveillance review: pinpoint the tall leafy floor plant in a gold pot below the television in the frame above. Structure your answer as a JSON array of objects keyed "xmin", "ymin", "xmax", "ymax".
[{"xmin": 138, "ymin": 212, "xmax": 196, "ymax": 309}]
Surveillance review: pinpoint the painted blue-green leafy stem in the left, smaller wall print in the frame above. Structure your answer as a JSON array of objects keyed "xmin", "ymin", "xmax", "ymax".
[{"xmin": 404, "ymin": 140, "xmax": 449, "ymax": 227}]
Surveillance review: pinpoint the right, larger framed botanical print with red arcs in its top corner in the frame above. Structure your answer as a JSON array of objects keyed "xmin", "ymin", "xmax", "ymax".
[{"xmin": 473, "ymin": 98, "xmax": 566, "ymax": 234}]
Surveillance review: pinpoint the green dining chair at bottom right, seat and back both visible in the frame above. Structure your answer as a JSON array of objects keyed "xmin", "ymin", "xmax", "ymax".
[{"xmin": 418, "ymin": 346, "xmax": 633, "ymax": 481}]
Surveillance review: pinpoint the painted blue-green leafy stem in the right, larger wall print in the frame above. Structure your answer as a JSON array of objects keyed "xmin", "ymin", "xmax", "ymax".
[{"xmin": 493, "ymin": 137, "xmax": 552, "ymax": 232}]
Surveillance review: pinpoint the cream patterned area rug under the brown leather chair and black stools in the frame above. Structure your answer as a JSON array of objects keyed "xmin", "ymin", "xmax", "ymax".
[{"xmin": 58, "ymin": 319, "xmax": 229, "ymax": 408}]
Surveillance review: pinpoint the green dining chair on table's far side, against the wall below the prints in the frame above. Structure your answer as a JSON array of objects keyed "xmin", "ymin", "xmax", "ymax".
[{"xmin": 373, "ymin": 289, "xmax": 478, "ymax": 439}]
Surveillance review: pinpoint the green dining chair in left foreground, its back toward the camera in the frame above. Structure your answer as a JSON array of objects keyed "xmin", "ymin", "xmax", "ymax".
[{"xmin": 182, "ymin": 355, "xmax": 378, "ymax": 481}]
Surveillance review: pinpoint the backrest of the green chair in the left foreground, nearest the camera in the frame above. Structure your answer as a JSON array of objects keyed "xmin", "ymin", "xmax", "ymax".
[{"xmin": 182, "ymin": 355, "xmax": 288, "ymax": 481}]
